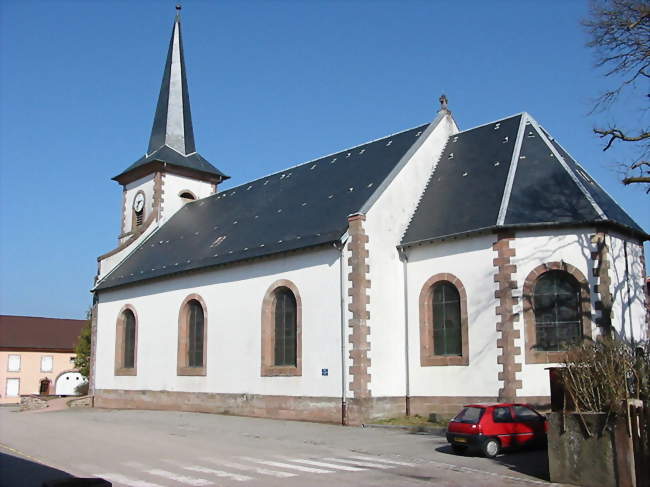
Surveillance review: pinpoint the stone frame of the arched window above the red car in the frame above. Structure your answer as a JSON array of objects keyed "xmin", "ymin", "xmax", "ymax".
[{"xmin": 419, "ymin": 272, "xmax": 469, "ymax": 367}]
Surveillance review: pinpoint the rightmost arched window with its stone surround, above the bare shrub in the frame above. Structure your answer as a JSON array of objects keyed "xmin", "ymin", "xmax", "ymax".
[{"xmin": 522, "ymin": 262, "xmax": 591, "ymax": 364}]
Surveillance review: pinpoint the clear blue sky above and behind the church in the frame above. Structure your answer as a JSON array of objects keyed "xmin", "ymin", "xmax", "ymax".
[{"xmin": 0, "ymin": 0, "xmax": 650, "ymax": 318}]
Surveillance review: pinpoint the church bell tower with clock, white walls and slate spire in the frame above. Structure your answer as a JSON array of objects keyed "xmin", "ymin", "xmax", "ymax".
[{"xmin": 113, "ymin": 5, "xmax": 228, "ymax": 246}]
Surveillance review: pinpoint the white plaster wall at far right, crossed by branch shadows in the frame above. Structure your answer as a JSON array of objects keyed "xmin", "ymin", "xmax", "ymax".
[{"xmin": 607, "ymin": 234, "xmax": 648, "ymax": 341}]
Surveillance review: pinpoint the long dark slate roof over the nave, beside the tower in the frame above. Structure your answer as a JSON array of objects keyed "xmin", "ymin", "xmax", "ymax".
[{"xmin": 95, "ymin": 122, "xmax": 430, "ymax": 290}]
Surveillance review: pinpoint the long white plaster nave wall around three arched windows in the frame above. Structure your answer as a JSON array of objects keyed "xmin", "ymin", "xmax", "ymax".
[{"xmin": 96, "ymin": 248, "xmax": 341, "ymax": 397}]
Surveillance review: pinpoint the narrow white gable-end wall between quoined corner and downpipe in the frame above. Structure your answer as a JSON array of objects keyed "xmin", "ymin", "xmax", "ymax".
[{"xmin": 364, "ymin": 117, "xmax": 458, "ymax": 397}]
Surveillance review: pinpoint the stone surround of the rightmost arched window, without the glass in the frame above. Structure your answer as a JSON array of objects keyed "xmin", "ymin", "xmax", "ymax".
[{"xmin": 522, "ymin": 262, "xmax": 592, "ymax": 364}]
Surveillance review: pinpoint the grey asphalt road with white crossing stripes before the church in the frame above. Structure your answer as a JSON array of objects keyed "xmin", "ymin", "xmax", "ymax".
[{"xmin": 0, "ymin": 407, "xmax": 551, "ymax": 487}]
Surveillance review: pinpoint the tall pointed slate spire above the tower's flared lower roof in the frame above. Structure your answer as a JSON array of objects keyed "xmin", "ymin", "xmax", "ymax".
[{"xmin": 147, "ymin": 5, "xmax": 196, "ymax": 155}]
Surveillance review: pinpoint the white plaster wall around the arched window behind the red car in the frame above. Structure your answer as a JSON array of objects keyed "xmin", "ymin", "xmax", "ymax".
[{"xmin": 408, "ymin": 235, "xmax": 499, "ymax": 397}]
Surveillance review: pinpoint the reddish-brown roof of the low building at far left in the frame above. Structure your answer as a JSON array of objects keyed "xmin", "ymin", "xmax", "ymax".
[{"xmin": 0, "ymin": 315, "xmax": 86, "ymax": 352}]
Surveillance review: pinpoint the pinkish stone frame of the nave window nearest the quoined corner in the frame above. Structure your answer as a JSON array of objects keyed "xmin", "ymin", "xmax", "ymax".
[{"xmin": 260, "ymin": 279, "xmax": 302, "ymax": 377}]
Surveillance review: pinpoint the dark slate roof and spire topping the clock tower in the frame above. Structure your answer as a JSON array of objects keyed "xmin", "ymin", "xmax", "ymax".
[{"xmin": 113, "ymin": 14, "xmax": 228, "ymax": 182}]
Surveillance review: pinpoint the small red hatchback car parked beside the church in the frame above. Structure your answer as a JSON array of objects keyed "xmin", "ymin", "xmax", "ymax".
[{"xmin": 447, "ymin": 403, "xmax": 548, "ymax": 458}]
